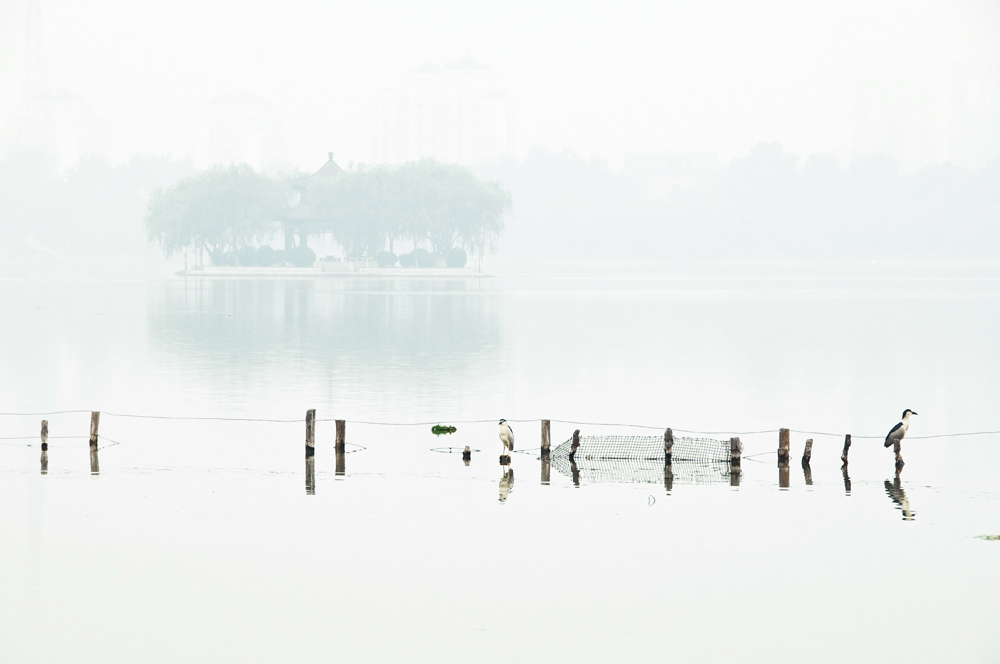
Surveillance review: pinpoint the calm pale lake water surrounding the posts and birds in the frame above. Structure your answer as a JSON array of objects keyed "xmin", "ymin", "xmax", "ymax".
[{"xmin": 0, "ymin": 270, "xmax": 1000, "ymax": 662}]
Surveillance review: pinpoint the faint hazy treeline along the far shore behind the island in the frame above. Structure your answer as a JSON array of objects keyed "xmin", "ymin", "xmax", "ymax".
[{"xmin": 0, "ymin": 144, "xmax": 1000, "ymax": 263}]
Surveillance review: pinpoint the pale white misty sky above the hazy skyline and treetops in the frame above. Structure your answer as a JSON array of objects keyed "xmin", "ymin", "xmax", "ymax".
[{"xmin": 0, "ymin": 0, "xmax": 1000, "ymax": 168}]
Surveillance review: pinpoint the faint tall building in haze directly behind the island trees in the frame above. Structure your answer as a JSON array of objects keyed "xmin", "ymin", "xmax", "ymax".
[{"xmin": 371, "ymin": 58, "xmax": 515, "ymax": 165}]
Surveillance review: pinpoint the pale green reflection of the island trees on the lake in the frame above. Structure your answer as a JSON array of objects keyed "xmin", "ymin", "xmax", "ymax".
[{"xmin": 147, "ymin": 277, "xmax": 500, "ymax": 410}]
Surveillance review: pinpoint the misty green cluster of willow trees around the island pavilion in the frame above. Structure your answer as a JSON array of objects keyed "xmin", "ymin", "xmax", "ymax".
[{"xmin": 146, "ymin": 159, "xmax": 512, "ymax": 267}]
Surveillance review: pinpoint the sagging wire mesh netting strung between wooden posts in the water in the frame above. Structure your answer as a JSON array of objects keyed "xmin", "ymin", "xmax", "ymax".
[{"xmin": 549, "ymin": 436, "xmax": 730, "ymax": 484}]
